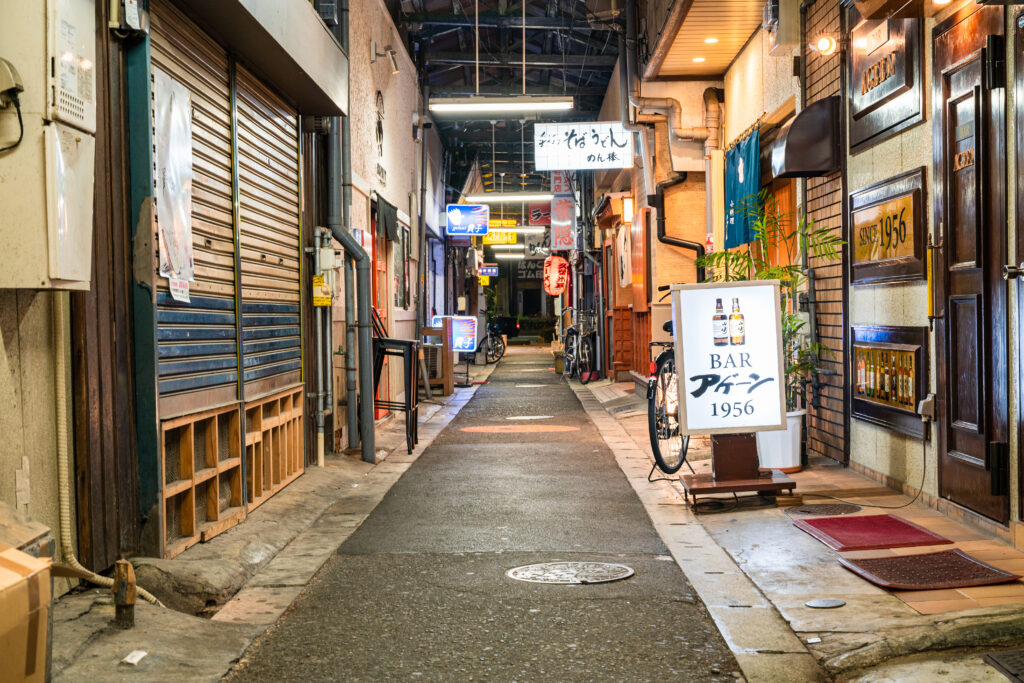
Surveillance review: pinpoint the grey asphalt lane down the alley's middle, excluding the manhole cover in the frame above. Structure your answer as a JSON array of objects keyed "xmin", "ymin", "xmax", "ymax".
[{"xmin": 232, "ymin": 349, "xmax": 739, "ymax": 681}]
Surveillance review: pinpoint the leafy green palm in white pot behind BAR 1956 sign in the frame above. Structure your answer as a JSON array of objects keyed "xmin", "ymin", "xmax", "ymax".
[{"xmin": 697, "ymin": 190, "xmax": 844, "ymax": 472}]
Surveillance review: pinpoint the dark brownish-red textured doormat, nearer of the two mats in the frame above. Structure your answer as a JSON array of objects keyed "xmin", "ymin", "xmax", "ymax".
[{"xmin": 839, "ymin": 549, "xmax": 1020, "ymax": 591}]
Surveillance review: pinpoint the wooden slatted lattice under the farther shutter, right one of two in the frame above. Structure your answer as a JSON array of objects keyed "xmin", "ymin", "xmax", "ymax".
[{"xmin": 245, "ymin": 386, "xmax": 305, "ymax": 512}]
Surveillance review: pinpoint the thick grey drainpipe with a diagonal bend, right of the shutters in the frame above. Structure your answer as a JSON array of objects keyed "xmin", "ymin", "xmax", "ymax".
[{"xmin": 327, "ymin": 117, "xmax": 377, "ymax": 463}]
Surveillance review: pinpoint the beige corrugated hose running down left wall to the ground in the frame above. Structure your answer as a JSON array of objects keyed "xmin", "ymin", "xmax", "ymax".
[{"xmin": 53, "ymin": 292, "xmax": 164, "ymax": 607}]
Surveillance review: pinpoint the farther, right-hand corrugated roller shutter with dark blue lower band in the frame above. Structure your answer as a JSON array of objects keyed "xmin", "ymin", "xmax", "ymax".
[{"xmin": 237, "ymin": 67, "xmax": 302, "ymax": 400}]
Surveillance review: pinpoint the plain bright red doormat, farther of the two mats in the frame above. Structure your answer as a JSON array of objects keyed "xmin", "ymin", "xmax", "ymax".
[{"xmin": 793, "ymin": 515, "xmax": 952, "ymax": 552}]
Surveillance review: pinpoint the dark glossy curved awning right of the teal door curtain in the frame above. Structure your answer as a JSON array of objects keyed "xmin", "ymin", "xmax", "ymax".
[{"xmin": 771, "ymin": 95, "xmax": 841, "ymax": 178}]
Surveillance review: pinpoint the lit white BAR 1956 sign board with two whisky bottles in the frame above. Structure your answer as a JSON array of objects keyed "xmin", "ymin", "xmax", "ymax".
[{"xmin": 672, "ymin": 280, "xmax": 785, "ymax": 434}]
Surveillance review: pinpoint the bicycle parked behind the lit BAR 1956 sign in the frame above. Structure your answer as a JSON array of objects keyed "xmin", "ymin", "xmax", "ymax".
[{"xmin": 647, "ymin": 286, "xmax": 693, "ymax": 474}]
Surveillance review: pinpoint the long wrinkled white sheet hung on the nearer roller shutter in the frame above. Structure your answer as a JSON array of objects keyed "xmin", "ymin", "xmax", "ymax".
[{"xmin": 153, "ymin": 68, "xmax": 196, "ymax": 281}]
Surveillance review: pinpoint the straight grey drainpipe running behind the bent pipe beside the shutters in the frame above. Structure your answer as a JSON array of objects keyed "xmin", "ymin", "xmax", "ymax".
[{"xmin": 339, "ymin": 0, "xmax": 359, "ymax": 451}]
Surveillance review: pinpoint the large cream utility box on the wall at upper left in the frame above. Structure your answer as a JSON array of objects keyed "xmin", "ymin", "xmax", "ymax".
[{"xmin": 0, "ymin": 0, "xmax": 100, "ymax": 290}]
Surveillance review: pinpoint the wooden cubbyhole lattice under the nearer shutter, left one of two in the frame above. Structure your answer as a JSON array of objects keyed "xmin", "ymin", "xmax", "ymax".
[{"xmin": 160, "ymin": 404, "xmax": 246, "ymax": 557}]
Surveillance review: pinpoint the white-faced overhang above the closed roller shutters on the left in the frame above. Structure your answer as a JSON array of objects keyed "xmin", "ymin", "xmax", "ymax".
[{"xmin": 175, "ymin": 0, "xmax": 348, "ymax": 116}]
